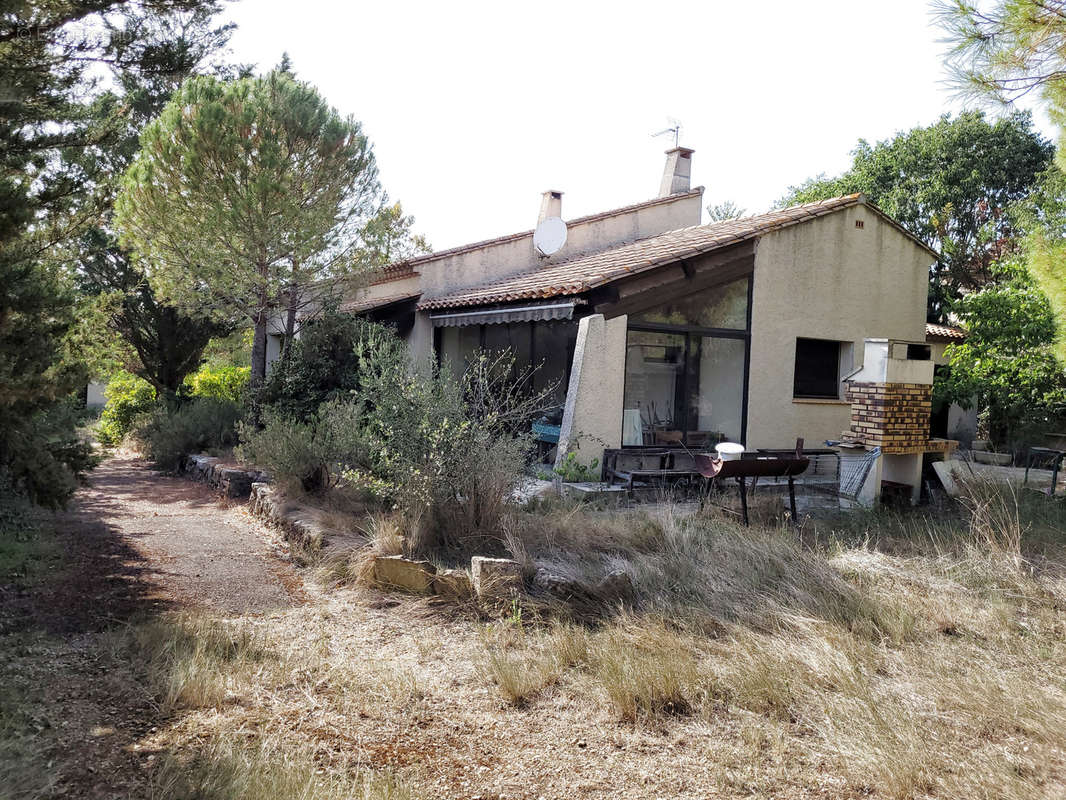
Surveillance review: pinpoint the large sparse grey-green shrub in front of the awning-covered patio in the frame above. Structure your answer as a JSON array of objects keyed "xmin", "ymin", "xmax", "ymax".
[{"xmin": 345, "ymin": 332, "xmax": 549, "ymax": 550}]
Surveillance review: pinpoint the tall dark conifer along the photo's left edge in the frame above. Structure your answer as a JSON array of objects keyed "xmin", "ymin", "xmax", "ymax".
[{"xmin": 0, "ymin": 0, "xmax": 227, "ymax": 505}]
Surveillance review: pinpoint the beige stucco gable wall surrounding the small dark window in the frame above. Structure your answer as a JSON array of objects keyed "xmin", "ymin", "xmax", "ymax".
[{"xmin": 744, "ymin": 206, "xmax": 933, "ymax": 448}]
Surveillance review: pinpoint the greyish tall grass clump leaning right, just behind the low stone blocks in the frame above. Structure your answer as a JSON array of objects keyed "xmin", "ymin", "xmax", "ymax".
[{"xmin": 507, "ymin": 503, "xmax": 912, "ymax": 642}]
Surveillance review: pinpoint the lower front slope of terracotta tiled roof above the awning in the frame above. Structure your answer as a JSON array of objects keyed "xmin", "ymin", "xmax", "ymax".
[{"xmin": 418, "ymin": 194, "xmax": 891, "ymax": 309}]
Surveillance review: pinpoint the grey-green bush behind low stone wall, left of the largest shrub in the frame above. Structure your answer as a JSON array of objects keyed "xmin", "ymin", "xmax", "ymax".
[{"xmin": 237, "ymin": 400, "xmax": 360, "ymax": 492}]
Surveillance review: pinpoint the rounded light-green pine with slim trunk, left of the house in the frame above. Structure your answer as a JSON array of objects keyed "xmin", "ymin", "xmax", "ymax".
[{"xmin": 116, "ymin": 68, "xmax": 405, "ymax": 386}]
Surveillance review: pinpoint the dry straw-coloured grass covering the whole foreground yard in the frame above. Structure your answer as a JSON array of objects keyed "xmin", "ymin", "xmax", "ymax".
[{"xmin": 12, "ymin": 480, "xmax": 1066, "ymax": 800}]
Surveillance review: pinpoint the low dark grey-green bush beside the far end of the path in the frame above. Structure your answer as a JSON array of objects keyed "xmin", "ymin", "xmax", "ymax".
[{"xmin": 133, "ymin": 398, "xmax": 243, "ymax": 469}]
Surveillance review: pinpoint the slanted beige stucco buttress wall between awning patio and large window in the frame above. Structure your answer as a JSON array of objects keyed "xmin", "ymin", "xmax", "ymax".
[{"xmin": 555, "ymin": 314, "xmax": 629, "ymax": 465}]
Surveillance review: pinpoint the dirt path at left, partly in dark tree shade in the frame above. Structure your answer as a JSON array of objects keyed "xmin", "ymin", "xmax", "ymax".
[{"xmin": 0, "ymin": 453, "xmax": 303, "ymax": 798}]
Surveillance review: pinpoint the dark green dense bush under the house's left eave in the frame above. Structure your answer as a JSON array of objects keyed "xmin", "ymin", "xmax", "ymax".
[{"xmin": 259, "ymin": 311, "xmax": 383, "ymax": 421}]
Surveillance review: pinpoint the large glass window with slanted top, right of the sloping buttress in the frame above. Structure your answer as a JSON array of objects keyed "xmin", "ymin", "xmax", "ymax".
[{"xmin": 621, "ymin": 277, "xmax": 748, "ymax": 448}]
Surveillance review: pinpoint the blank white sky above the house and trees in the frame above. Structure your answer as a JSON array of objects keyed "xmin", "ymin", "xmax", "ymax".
[{"xmin": 220, "ymin": 0, "xmax": 1049, "ymax": 250}]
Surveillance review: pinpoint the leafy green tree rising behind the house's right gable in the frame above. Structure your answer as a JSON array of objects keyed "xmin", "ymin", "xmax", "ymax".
[{"xmin": 781, "ymin": 111, "xmax": 1053, "ymax": 321}]
